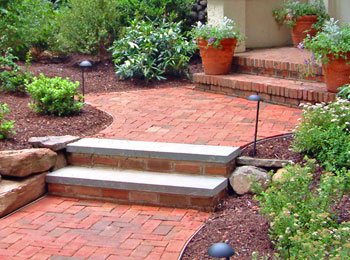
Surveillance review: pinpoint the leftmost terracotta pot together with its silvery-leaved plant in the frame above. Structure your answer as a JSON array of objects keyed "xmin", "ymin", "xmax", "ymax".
[{"xmin": 191, "ymin": 17, "xmax": 245, "ymax": 75}]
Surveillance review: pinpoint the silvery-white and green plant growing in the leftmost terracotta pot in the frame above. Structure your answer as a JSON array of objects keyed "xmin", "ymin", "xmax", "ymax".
[{"xmin": 191, "ymin": 17, "xmax": 245, "ymax": 49}]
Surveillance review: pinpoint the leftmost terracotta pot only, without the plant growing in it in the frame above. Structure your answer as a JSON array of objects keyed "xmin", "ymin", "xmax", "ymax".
[{"xmin": 197, "ymin": 38, "xmax": 237, "ymax": 75}]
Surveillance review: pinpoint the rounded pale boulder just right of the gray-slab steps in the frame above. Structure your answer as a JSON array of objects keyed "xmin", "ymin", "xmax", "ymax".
[{"xmin": 229, "ymin": 166, "xmax": 268, "ymax": 195}]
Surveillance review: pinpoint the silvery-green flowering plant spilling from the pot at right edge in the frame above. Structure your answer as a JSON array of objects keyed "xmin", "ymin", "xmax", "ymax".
[{"xmin": 299, "ymin": 18, "xmax": 350, "ymax": 64}]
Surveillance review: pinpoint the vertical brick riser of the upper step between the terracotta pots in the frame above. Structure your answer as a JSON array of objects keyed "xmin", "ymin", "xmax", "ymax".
[{"xmin": 232, "ymin": 57, "xmax": 324, "ymax": 82}]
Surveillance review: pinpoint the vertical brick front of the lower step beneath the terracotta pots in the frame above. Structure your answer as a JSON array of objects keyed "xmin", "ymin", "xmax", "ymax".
[{"xmin": 194, "ymin": 74, "xmax": 336, "ymax": 107}]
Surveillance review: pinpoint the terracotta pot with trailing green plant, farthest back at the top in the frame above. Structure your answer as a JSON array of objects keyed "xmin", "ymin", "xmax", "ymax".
[{"xmin": 273, "ymin": 0, "xmax": 329, "ymax": 47}]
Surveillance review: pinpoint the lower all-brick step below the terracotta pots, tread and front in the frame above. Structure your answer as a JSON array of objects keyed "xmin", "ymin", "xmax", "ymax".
[{"xmin": 193, "ymin": 73, "xmax": 336, "ymax": 106}]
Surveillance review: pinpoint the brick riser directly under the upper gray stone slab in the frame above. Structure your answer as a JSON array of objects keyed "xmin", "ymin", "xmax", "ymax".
[{"xmin": 68, "ymin": 153, "xmax": 235, "ymax": 177}]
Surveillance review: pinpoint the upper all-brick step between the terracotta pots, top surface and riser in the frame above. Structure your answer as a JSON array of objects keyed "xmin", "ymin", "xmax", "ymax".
[{"xmin": 232, "ymin": 47, "xmax": 324, "ymax": 82}]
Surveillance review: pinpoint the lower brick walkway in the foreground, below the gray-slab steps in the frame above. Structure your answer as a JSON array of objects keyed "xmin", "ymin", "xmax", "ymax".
[{"xmin": 0, "ymin": 196, "xmax": 209, "ymax": 260}]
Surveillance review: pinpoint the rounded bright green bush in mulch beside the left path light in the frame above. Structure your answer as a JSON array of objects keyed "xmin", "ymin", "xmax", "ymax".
[{"xmin": 27, "ymin": 74, "xmax": 84, "ymax": 116}]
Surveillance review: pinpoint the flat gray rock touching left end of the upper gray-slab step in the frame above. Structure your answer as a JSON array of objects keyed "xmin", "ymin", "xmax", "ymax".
[{"xmin": 28, "ymin": 135, "xmax": 80, "ymax": 151}]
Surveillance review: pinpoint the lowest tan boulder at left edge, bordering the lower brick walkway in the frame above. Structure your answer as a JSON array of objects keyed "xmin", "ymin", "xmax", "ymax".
[{"xmin": 0, "ymin": 173, "xmax": 46, "ymax": 218}]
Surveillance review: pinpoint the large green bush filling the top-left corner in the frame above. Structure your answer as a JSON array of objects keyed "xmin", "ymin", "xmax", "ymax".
[{"xmin": 0, "ymin": 0, "xmax": 55, "ymax": 58}]
